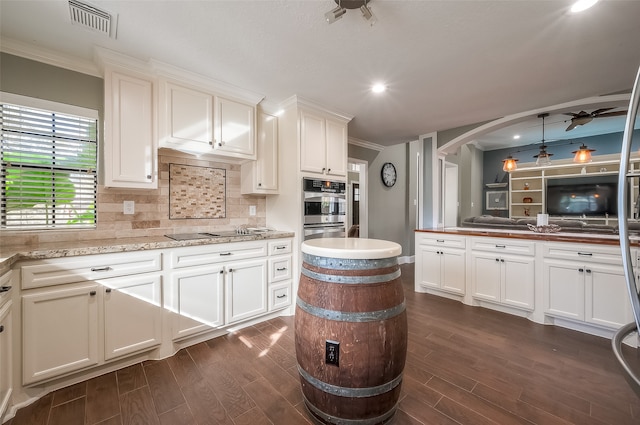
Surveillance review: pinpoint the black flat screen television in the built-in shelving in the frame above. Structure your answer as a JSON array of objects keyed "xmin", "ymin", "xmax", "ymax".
[{"xmin": 547, "ymin": 175, "xmax": 618, "ymax": 217}]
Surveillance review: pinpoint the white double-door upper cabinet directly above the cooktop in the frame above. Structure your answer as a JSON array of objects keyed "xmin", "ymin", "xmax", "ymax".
[{"xmin": 160, "ymin": 79, "xmax": 256, "ymax": 160}]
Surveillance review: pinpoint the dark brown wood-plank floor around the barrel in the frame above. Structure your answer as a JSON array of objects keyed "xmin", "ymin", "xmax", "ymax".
[{"xmin": 8, "ymin": 264, "xmax": 640, "ymax": 425}]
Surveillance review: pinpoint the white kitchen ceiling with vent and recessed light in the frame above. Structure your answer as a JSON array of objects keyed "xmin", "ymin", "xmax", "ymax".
[{"xmin": 0, "ymin": 0, "xmax": 640, "ymax": 149}]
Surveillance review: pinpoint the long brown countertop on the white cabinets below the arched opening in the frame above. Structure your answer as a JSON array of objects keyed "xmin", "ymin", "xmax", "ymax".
[{"xmin": 416, "ymin": 227, "xmax": 640, "ymax": 246}]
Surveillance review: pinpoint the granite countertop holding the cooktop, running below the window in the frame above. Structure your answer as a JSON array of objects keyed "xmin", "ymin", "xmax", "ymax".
[{"xmin": 0, "ymin": 230, "xmax": 295, "ymax": 274}]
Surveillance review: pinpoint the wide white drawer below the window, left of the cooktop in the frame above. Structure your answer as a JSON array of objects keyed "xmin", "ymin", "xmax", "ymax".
[{"xmin": 21, "ymin": 251, "xmax": 162, "ymax": 289}]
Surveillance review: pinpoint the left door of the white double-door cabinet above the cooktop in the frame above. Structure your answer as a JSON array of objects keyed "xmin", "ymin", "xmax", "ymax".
[{"xmin": 165, "ymin": 83, "xmax": 214, "ymax": 147}]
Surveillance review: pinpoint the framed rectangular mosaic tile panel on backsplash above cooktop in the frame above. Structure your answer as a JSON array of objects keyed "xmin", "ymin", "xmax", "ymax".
[{"xmin": 169, "ymin": 164, "xmax": 227, "ymax": 219}]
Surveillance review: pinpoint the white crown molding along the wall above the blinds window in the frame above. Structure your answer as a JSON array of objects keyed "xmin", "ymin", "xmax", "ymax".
[{"xmin": 0, "ymin": 37, "xmax": 102, "ymax": 77}]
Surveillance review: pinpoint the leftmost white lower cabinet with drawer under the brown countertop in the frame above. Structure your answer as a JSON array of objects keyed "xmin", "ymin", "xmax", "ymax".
[{"xmin": 415, "ymin": 238, "xmax": 466, "ymax": 295}]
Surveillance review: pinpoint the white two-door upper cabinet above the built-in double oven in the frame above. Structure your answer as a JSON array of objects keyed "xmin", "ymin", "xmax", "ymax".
[{"xmin": 300, "ymin": 110, "xmax": 348, "ymax": 176}]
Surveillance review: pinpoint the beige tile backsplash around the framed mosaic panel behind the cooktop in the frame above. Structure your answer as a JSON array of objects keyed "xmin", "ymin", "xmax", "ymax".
[{"xmin": 0, "ymin": 149, "xmax": 266, "ymax": 246}]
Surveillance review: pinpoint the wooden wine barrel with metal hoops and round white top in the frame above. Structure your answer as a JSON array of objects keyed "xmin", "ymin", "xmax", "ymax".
[{"xmin": 295, "ymin": 238, "xmax": 407, "ymax": 425}]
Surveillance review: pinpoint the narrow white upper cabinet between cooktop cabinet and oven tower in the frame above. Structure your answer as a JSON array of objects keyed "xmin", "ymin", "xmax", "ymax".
[{"xmin": 240, "ymin": 112, "xmax": 278, "ymax": 195}]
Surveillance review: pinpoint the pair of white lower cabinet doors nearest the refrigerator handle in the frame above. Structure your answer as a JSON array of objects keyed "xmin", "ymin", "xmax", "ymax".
[{"xmin": 543, "ymin": 259, "xmax": 633, "ymax": 329}]
